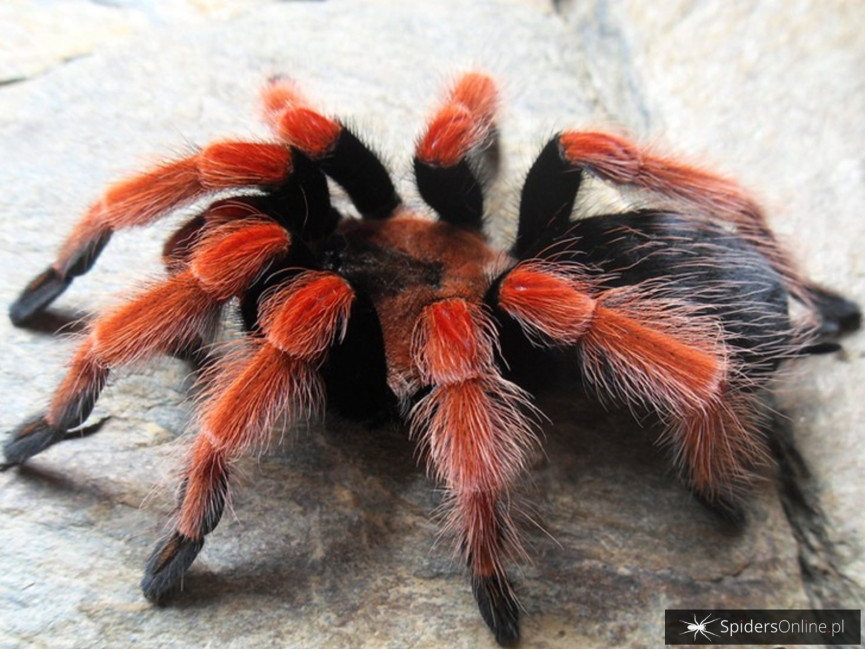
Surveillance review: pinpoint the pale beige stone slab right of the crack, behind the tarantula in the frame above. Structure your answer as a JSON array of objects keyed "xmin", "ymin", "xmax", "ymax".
[{"xmin": 623, "ymin": 2, "xmax": 865, "ymax": 599}]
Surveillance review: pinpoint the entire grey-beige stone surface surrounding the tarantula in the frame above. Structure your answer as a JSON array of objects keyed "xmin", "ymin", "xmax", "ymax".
[{"xmin": 0, "ymin": 0, "xmax": 865, "ymax": 648}]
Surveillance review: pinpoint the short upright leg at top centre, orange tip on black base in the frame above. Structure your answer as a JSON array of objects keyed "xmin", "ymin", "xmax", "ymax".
[{"xmin": 414, "ymin": 72, "xmax": 499, "ymax": 229}]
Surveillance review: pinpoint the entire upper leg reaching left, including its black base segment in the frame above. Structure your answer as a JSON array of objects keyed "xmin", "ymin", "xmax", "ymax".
[{"xmin": 9, "ymin": 141, "xmax": 335, "ymax": 324}]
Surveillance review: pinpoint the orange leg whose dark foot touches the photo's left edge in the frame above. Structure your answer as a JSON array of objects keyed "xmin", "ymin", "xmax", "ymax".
[{"xmin": 4, "ymin": 220, "xmax": 289, "ymax": 464}]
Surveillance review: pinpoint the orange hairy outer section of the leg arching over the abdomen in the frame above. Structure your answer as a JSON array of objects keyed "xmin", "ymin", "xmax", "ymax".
[{"xmin": 558, "ymin": 131, "xmax": 810, "ymax": 304}]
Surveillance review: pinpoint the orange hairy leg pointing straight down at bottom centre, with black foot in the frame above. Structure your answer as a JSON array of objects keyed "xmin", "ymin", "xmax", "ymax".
[{"xmin": 411, "ymin": 298, "xmax": 536, "ymax": 644}]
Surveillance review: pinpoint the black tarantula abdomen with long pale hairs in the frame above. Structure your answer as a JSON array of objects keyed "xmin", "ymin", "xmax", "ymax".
[{"xmin": 546, "ymin": 210, "xmax": 797, "ymax": 376}]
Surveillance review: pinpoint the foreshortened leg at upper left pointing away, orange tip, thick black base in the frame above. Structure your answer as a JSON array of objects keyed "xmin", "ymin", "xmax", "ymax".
[{"xmin": 262, "ymin": 77, "xmax": 402, "ymax": 219}]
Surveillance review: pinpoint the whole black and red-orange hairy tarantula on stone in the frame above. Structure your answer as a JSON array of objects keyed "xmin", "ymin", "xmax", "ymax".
[{"xmin": 4, "ymin": 73, "xmax": 859, "ymax": 645}]
